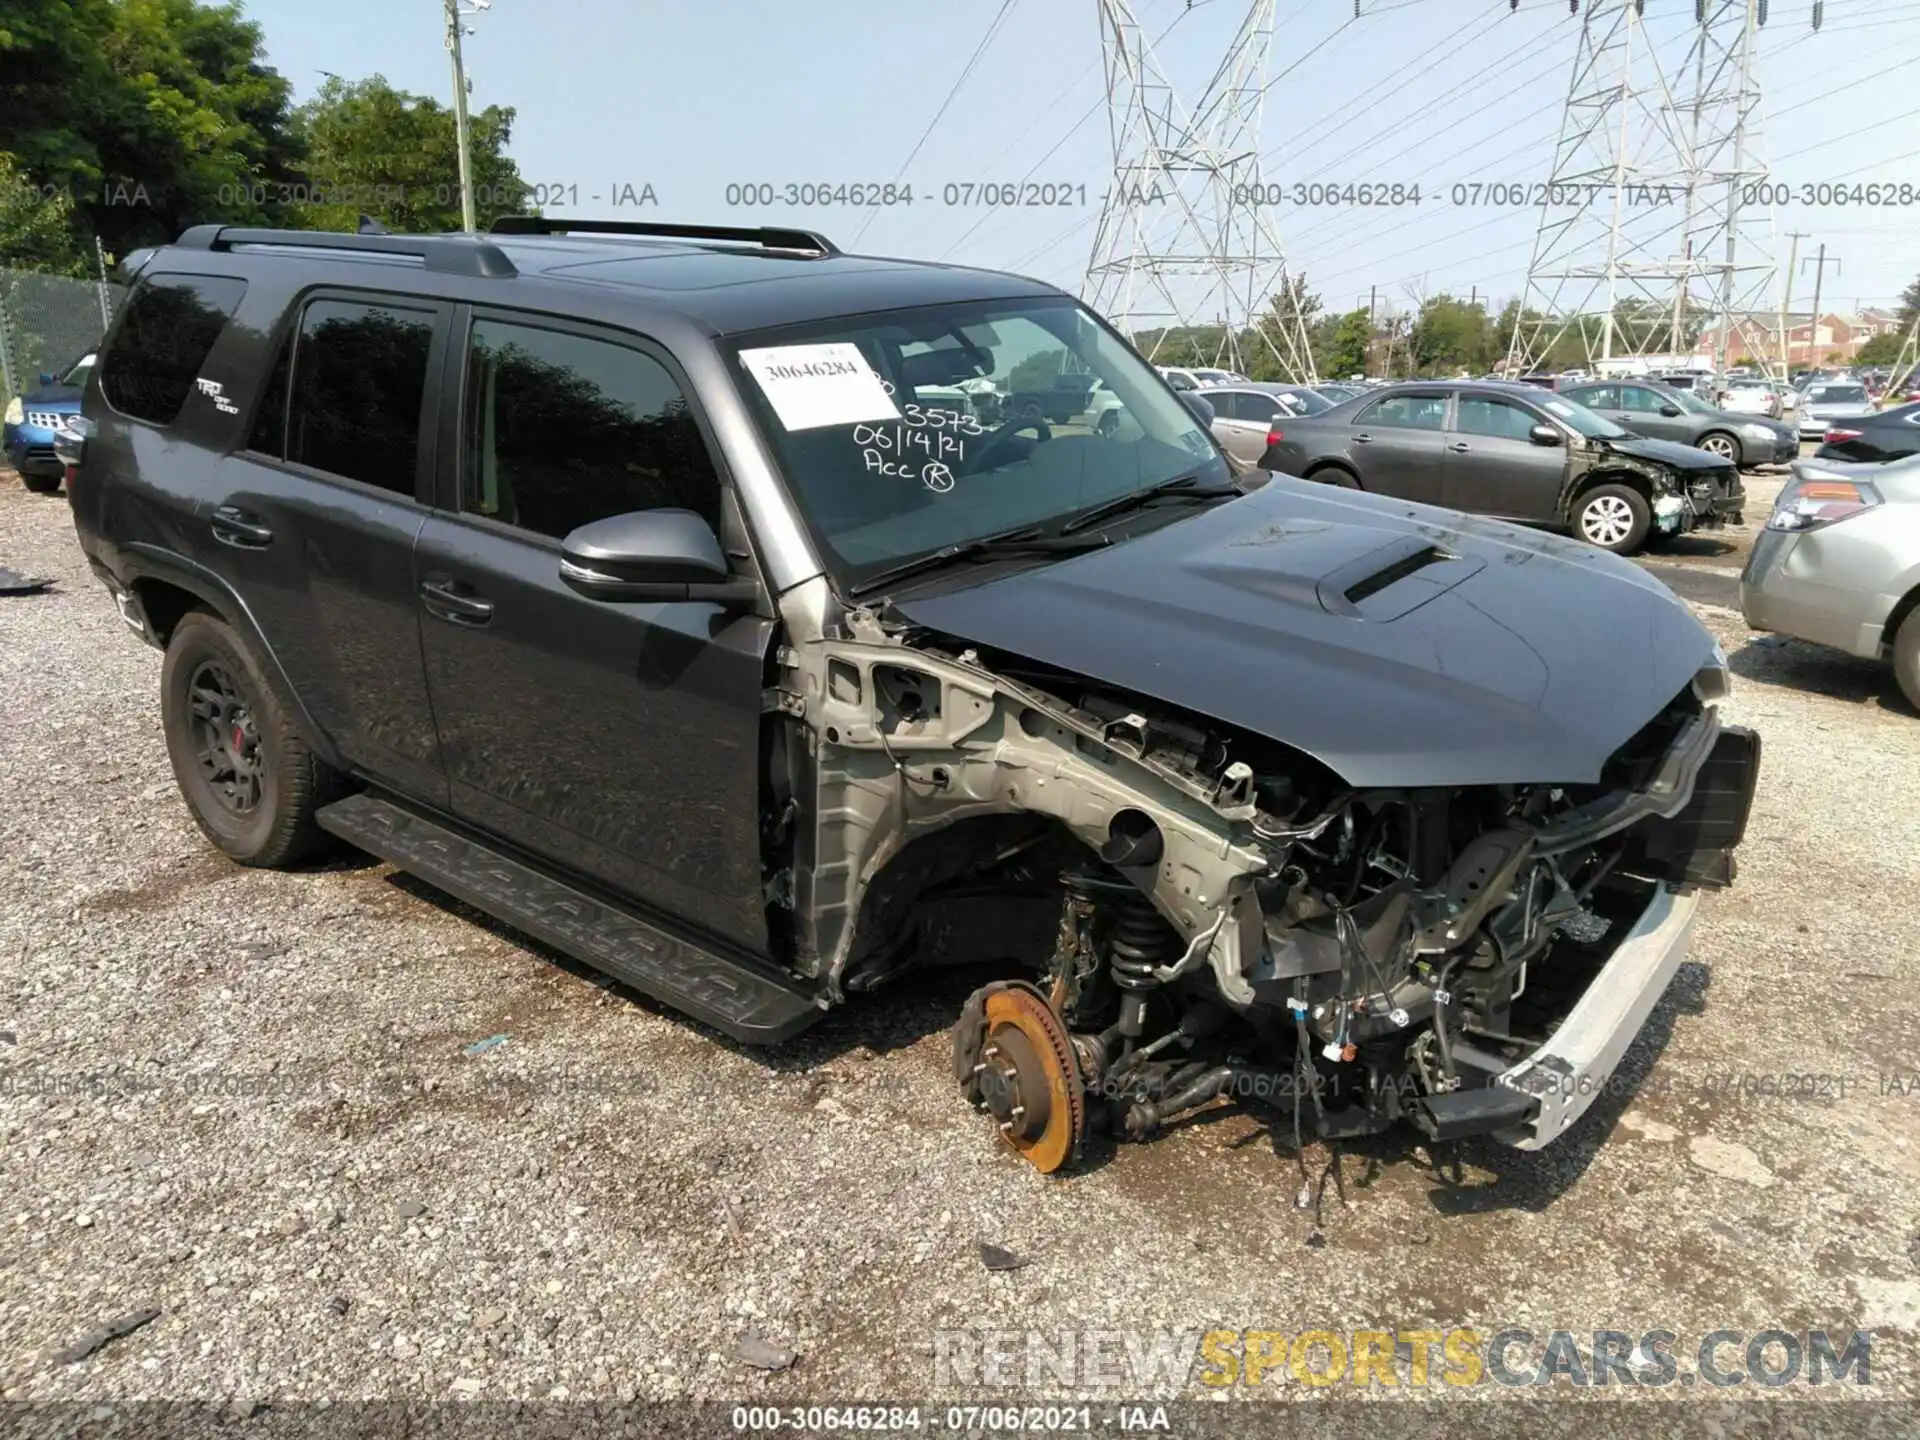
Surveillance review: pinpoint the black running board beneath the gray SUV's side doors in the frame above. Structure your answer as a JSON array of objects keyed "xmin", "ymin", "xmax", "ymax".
[{"xmin": 315, "ymin": 795, "xmax": 826, "ymax": 1044}]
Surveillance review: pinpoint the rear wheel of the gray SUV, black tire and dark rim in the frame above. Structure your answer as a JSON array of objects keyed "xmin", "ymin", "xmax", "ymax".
[{"xmin": 159, "ymin": 611, "xmax": 340, "ymax": 870}]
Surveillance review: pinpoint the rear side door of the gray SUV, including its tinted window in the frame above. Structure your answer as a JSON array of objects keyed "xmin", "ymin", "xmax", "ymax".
[{"xmin": 171, "ymin": 290, "xmax": 451, "ymax": 804}]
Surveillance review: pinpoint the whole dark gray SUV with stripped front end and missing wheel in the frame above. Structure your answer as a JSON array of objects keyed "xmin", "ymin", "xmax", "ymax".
[{"xmin": 65, "ymin": 217, "xmax": 1759, "ymax": 1171}]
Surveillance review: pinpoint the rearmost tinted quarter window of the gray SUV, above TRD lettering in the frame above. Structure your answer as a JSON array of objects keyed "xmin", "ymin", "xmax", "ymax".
[{"xmin": 100, "ymin": 275, "xmax": 246, "ymax": 424}]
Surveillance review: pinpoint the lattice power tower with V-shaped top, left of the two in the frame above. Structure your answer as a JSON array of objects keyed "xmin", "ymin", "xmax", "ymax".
[{"xmin": 1081, "ymin": 0, "xmax": 1317, "ymax": 380}]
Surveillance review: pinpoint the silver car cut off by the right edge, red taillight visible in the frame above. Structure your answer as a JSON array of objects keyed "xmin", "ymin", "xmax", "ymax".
[{"xmin": 1740, "ymin": 455, "xmax": 1920, "ymax": 708}]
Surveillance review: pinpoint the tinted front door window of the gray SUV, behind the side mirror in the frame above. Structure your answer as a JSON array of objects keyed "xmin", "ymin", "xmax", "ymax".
[{"xmin": 461, "ymin": 321, "xmax": 720, "ymax": 540}]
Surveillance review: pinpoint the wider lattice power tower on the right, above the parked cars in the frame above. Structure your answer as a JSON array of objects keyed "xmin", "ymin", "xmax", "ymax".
[{"xmin": 1507, "ymin": 0, "xmax": 1776, "ymax": 378}]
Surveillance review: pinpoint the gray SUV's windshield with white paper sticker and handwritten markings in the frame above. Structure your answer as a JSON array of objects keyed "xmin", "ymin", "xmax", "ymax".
[{"xmin": 733, "ymin": 296, "xmax": 1231, "ymax": 586}]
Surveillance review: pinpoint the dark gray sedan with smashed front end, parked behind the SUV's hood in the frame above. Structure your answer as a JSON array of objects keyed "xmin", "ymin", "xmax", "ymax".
[{"xmin": 1261, "ymin": 380, "xmax": 1745, "ymax": 555}]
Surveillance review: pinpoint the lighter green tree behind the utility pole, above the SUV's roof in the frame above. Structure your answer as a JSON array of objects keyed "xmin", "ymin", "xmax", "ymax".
[{"xmin": 294, "ymin": 75, "xmax": 530, "ymax": 232}]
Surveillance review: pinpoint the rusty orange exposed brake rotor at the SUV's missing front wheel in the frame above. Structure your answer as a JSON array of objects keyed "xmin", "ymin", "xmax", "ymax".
[{"xmin": 954, "ymin": 981, "xmax": 1087, "ymax": 1175}]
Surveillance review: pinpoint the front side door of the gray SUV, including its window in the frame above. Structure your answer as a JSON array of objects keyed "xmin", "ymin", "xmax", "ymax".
[{"xmin": 415, "ymin": 311, "xmax": 772, "ymax": 954}]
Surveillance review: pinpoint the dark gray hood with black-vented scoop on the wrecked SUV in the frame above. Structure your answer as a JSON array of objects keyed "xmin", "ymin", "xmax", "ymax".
[{"xmin": 895, "ymin": 476, "xmax": 1713, "ymax": 787}]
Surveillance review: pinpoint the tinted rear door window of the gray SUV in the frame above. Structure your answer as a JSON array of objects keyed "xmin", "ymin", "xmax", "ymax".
[{"xmin": 250, "ymin": 300, "xmax": 434, "ymax": 497}]
